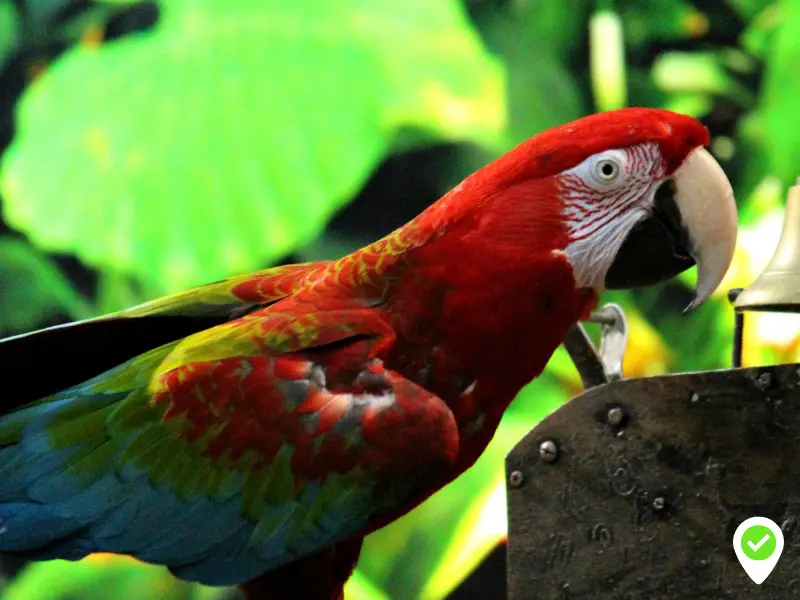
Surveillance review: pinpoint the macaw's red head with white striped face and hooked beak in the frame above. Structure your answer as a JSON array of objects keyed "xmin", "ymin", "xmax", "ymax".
[{"xmin": 465, "ymin": 108, "xmax": 737, "ymax": 310}]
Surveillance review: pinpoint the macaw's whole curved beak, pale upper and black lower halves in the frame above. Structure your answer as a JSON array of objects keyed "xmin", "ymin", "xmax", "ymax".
[{"xmin": 605, "ymin": 148, "xmax": 738, "ymax": 311}]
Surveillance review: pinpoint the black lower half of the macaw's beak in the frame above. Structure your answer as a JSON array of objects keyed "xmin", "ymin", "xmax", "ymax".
[{"xmin": 605, "ymin": 180, "xmax": 695, "ymax": 290}]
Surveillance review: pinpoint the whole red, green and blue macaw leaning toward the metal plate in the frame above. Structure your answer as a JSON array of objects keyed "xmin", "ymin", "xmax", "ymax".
[{"xmin": 0, "ymin": 107, "xmax": 738, "ymax": 600}]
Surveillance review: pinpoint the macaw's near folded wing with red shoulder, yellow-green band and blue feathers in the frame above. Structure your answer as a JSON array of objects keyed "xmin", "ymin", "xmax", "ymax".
[{"xmin": 0, "ymin": 298, "xmax": 458, "ymax": 585}]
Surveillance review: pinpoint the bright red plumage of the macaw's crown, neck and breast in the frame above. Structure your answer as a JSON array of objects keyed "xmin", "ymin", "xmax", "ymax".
[{"xmin": 227, "ymin": 109, "xmax": 709, "ymax": 596}]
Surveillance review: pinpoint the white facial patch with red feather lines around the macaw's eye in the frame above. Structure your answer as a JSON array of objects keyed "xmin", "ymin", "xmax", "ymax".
[{"xmin": 558, "ymin": 144, "xmax": 665, "ymax": 290}]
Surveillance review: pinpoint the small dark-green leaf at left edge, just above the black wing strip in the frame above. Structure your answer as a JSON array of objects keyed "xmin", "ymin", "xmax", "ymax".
[{"xmin": 0, "ymin": 237, "xmax": 91, "ymax": 333}]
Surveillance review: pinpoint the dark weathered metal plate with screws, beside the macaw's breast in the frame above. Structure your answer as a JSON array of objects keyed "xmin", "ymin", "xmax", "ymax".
[{"xmin": 506, "ymin": 364, "xmax": 800, "ymax": 600}]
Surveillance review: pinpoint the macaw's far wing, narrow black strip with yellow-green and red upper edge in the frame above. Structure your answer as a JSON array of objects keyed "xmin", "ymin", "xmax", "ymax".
[{"xmin": 0, "ymin": 262, "xmax": 328, "ymax": 414}]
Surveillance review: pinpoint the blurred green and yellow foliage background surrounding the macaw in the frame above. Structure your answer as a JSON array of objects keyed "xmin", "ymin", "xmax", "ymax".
[{"xmin": 0, "ymin": 0, "xmax": 800, "ymax": 600}]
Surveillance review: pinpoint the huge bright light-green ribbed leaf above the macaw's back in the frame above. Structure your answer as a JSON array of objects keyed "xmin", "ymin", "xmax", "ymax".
[{"xmin": 0, "ymin": 0, "xmax": 504, "ymax": 290}]
